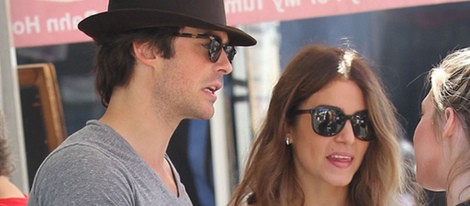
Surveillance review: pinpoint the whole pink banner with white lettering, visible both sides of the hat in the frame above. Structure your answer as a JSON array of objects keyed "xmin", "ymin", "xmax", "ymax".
[{"xmin": 10, "ymin": 0, "xmax": 464, "ymax": 47}]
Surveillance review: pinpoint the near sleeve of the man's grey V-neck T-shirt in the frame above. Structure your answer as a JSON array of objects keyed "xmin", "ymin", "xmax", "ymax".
[{"xmin": 28, "ymin": 145, "xmax": 135, "ymax": 206}]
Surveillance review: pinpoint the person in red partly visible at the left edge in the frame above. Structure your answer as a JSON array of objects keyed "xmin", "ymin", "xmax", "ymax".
[{"xmin": 0, "ymin": 112, "xmax": 27, "ymax": 206}]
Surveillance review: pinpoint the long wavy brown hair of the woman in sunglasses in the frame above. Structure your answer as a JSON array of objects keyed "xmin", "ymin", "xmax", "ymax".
[{"xmin": 229, "ymin": 45, "xmax": 414, "ymax": 206}]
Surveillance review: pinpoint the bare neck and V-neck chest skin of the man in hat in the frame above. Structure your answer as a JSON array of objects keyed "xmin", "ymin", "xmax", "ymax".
[{"xmin": 100, "ymin": 99, "xmax": 179, "ymax": 196}]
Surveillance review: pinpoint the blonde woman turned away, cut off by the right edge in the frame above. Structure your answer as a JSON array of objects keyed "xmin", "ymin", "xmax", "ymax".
[{"xmin": 414, "ymin": 48, "xmax": 470, "ymax": 206}]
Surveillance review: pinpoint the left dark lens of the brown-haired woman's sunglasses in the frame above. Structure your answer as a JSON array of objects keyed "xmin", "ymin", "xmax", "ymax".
[{"xmin": 312, "ymin": 107, "xmax": 345, "ymax": 137}]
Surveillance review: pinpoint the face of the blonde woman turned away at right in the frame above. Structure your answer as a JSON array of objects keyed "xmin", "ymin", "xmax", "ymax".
[{"xmin": 413, "ymin": 93, "xmax": 447, "ymax": 191}]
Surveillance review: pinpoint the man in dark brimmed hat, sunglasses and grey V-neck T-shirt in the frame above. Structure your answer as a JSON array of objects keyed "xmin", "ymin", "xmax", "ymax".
[{"xmin": 29, "ymin": 0, "xmax": 256, "ymax": 206}]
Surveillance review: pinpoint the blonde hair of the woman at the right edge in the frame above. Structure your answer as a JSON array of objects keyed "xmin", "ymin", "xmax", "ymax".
[{"xmin": 429, "ymin": 48, "xmax": 470, "ymax": 202}]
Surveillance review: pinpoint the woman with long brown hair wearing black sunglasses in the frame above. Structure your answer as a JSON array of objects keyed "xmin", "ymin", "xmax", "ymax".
[{"xmin": 230, "ymin": 45, "xmax": 416, "ymax": 206}]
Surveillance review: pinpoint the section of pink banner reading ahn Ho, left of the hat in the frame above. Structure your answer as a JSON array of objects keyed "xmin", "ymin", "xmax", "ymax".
[{"xmin": 10, "ymin": 0, "xmax": 107, "ymax": 47}]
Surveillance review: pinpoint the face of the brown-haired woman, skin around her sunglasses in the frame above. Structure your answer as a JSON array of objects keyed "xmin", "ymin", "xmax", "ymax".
[{"xmin": 288, "ymin": 80, "xmax": 369, "ymax": 187}]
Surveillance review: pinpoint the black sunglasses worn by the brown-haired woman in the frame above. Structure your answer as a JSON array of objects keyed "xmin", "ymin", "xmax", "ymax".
[{"xmin": 295, "ymin": 106, "xmax": 375, "ymax": 141}]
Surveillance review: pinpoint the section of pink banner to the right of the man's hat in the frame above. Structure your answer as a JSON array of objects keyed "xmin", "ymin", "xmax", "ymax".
[{"xmin": 225, "ymin": 0, "xmax": 464, "ymax": 25}]
